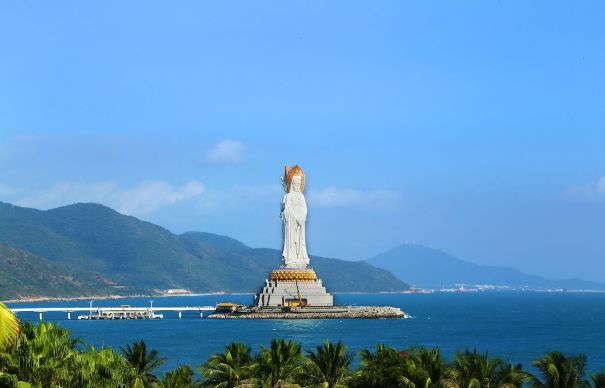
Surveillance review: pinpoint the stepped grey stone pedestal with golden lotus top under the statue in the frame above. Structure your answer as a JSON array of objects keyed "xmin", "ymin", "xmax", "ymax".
[{"xmin": 255, "ymin": 268, "xmax": 334, "ymax": 307}]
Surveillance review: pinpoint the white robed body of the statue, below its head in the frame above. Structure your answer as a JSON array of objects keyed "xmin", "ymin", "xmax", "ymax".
[{"xmin": 282, "ymin": 191, "xmax": 309, "ymax": 268}]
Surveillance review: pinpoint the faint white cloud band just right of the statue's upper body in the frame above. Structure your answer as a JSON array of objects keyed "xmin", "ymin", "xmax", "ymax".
[{"xmin": 308, "ymin": 186, "xmax": 401, "ymax": 207}]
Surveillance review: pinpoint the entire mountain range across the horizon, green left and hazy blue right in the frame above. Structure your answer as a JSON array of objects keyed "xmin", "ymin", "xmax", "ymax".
[{"xmin": 0, "ymin": 202, "xmax": 605, "ymax": 300}]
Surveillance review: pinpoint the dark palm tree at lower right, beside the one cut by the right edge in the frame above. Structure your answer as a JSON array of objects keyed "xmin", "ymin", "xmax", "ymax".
[{"xmin": 529, "ymin": 351, "xmax": 590, "ymax": 388}]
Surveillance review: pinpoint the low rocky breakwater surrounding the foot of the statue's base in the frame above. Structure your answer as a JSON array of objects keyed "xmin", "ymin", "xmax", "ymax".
[{"xmin": 209, "ymin": 306, "xmax": 407, "ymax": 319}]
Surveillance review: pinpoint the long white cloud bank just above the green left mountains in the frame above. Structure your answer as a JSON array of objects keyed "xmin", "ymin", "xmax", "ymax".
[{"xmin": 16, "ymin": 180, "xmax": 205, "ymax": 215}]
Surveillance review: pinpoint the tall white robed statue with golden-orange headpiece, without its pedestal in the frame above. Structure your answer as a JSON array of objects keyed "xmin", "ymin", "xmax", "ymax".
[{"xmin": 281, "ymin": 165, "xmax": 309, "ymax": 269}]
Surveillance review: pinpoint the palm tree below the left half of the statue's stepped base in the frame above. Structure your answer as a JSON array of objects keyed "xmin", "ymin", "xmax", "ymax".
[{"xmin": 253, "ymin": 338, "xmax": 302, "ymax": 387}]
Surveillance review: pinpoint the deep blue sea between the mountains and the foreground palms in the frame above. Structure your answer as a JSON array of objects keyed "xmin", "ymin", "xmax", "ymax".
[{"xmin": 9, "ymin": 292, "xmax": 605, "ymax": 372}]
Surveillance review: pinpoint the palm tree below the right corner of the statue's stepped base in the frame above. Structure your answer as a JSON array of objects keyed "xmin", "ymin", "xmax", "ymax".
[{"xmin": 307, "ymin": 339, "xmax": 355, "ymax": 388}]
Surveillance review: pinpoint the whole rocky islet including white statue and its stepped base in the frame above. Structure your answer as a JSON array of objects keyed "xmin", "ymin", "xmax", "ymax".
[{"xmin": 210, "ymin": 165, "xmax": 406, "ymax": 319}]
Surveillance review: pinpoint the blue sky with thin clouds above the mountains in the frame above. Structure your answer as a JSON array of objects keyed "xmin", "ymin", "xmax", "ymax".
[{"xmin": 0, "ymin": 0, "xmax": 605, "ymax": 282}]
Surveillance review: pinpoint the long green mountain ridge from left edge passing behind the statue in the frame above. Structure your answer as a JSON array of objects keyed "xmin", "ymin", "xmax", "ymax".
[{"xmin": 0, "ymin": 202, "xmax": 408, "ymax": 299}]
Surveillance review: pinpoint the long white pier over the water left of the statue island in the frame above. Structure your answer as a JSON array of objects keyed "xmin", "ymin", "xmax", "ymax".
[{"xmin": 11, "ymin": 306, "xmax": 216, "ymax": 320}]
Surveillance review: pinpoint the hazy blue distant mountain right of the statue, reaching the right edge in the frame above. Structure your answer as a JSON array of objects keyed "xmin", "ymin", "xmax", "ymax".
[{"xmin": 367, "ymin": 244, "xmax": 605, "ymax": 290}]
